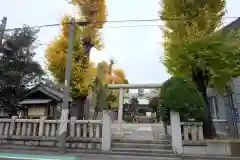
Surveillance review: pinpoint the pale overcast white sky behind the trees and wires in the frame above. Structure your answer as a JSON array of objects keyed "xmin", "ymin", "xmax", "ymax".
[{"xmin": 0, "ymin": 0, "xmax": 240, "ymax": 83}]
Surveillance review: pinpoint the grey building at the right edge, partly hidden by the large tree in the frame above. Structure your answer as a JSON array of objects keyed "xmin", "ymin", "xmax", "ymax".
[{"xmin": 207, "ymin": 18, "xmax": 240, "ymax": 134}]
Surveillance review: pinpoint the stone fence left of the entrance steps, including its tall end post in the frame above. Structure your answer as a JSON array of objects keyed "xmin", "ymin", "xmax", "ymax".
[{"xmin": 0, "ymin": 113, "xmax": 111, "ymax": 150}]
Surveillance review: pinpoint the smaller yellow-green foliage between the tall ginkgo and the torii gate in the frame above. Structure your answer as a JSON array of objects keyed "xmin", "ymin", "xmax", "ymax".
[{"xmin": 90, "ymin": 61, "xmax": 128, "ymax": 118}]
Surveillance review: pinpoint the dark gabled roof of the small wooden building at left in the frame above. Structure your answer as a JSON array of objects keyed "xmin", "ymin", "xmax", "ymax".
[{"xmin": 23, "ymin": 84, "xmax": 72, "ymax": 101}]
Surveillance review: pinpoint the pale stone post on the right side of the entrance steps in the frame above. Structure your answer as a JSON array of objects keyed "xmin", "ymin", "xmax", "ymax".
[{"xmin": 170, "ymin": 111, "xmax": 183, "ymax": 154}]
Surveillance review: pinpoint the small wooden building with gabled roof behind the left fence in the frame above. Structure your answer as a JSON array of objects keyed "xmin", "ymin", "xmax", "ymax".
[{"xmin": 18, "ymin": 84, "xmax": 72, "ymax": 119}]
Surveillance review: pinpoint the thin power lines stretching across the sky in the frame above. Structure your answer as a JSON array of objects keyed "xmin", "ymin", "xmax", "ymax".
[{"xmin": 5, "ymin": 17, "xmax": 240, "ymax": 31}]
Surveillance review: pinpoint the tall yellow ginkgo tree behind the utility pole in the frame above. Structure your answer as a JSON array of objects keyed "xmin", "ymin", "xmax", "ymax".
[{"xmin": 46, "ymin": 0, "xmax": 106, "ymax": 118}]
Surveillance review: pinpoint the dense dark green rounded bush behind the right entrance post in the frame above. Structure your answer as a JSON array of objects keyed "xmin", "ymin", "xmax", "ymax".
[{"xmin": 158, "ymin": 77, "xmax": 206, "ymax": 124}]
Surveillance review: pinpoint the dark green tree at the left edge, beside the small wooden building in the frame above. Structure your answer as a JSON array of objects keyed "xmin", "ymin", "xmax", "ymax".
[{"xmin": 0, "ymin": 26, "xmax": 44, "ymax": 114}]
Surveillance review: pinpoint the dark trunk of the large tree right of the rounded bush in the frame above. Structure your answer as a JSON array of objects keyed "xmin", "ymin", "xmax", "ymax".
[{"xmin": 193, "ymin": 69, "xmax": 217, "ymax": 139}]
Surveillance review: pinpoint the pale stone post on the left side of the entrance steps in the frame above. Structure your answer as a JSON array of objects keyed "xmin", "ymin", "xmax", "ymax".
[{"xmin": 101, "ymin": 111, "xmax": 112, "ymax": 151}]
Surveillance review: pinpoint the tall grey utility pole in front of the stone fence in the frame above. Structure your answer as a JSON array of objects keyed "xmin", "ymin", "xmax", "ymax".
[{"xmin": 59, "ymin": 18, "xmax": 75, "ymax": 153}]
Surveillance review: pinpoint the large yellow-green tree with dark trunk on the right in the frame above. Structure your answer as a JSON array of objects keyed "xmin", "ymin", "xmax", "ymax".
[{"xmin": 161, "ymin": 0, "xmax": 240, "ymax": 138}]
